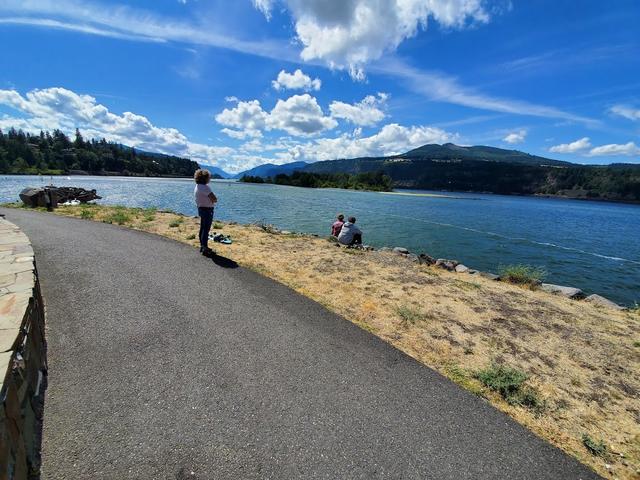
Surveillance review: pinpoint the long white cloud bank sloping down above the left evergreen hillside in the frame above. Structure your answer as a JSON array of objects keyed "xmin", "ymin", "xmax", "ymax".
[{"xmin": 0, "ymin": 88, "xmax": 233, "ymax": 168}]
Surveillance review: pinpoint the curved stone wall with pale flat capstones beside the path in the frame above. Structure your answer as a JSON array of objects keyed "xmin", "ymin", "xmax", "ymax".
[{"xmin": 0, "ymin": 217, "xmax": 47, "ymax": 480}]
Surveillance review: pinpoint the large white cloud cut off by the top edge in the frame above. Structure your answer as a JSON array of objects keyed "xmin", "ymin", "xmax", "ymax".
[{"xmin": 254, "ymin": 0, "xmax": 489, "ymax": 79}]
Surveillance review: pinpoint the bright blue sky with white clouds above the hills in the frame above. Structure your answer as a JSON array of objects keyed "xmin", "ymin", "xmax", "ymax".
[{"xmin": 0, "ymin": 0, "xmax": 640, "ymax": 173}]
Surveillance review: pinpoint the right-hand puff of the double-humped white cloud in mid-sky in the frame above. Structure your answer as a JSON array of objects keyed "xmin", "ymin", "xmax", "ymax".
[{"xmin": 268, "ymin": 93, "xmax": 338, "ymax": 136}]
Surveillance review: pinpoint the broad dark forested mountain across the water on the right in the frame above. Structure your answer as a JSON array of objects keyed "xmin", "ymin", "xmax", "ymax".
[{"xmin": 304, "ymin": 143, "xmax": 640, "ymax": 202}]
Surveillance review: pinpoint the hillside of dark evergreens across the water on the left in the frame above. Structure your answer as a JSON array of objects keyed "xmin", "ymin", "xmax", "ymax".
[{"xmin": 0, "ymin": 128, "xmax": 198, "ymax": 177}]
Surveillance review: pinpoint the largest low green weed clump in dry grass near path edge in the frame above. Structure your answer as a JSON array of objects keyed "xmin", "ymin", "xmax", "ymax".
[{"xmin": 474, "ymin": 362, "xmax": 546, "ymax": 414}]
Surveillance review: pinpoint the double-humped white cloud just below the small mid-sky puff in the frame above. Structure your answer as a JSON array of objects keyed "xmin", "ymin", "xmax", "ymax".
[{"xmin": 215, "ymin": 93, "xmax": 338, "ymax": 138}]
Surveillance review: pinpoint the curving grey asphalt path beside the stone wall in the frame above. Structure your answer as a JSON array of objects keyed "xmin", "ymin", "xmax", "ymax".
[{"xmin": 2, "ymin": 209, "xmax": 598, "ymax": 480}]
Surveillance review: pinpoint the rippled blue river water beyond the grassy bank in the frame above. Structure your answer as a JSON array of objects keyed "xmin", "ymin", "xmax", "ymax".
[{"xmin": 0, "ymin": 176, "xmax": 640, "ymax": 305}]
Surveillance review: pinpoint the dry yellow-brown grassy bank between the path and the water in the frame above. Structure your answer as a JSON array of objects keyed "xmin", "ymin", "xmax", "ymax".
[{"xmin": 6, "ymin": 206, "xmax": 640, "ymax": 479}]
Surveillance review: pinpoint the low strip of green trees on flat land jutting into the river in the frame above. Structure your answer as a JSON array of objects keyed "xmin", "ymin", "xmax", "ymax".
[{"xmin": 240, "ymin": 171, "xmax": 393, "ymax": 192}]
